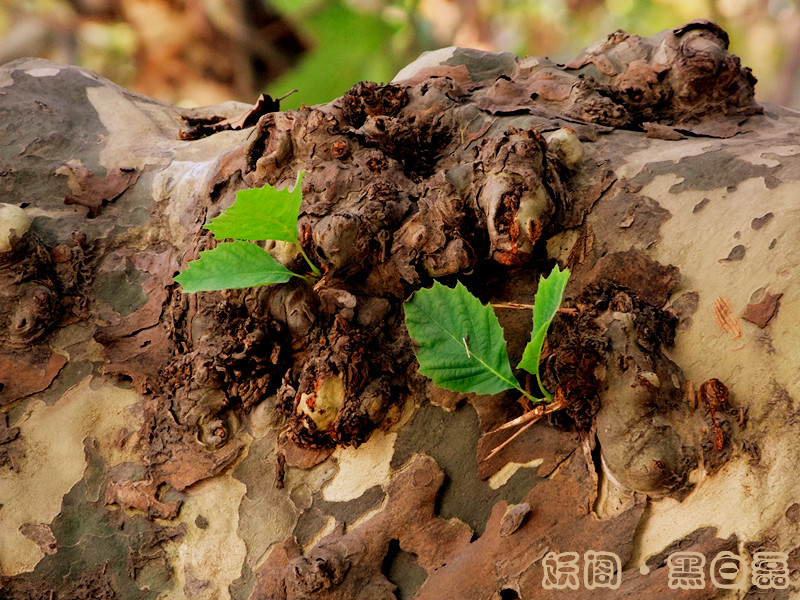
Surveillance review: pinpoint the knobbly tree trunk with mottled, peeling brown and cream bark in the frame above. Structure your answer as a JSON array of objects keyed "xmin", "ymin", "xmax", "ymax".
[{"xmin": 0, "ymin": 22, "xmax": 800, "ymax": 600}]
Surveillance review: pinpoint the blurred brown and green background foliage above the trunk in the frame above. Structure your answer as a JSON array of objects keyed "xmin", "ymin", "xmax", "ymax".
[{"xmin": 0, "ymin": 0, "xmax": 800, "ymax": 108}]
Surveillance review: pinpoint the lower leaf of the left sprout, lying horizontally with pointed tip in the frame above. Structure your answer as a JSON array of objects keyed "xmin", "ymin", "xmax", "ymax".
[{"xmin": 175, "ymin": 241, "xmax": 294, "ymax": 293}]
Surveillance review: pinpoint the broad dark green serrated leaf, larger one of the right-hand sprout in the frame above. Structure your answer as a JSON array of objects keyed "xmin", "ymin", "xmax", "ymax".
[{"xmin": 404, "ymin": 281, "xmax": 520, "ymax": 394}]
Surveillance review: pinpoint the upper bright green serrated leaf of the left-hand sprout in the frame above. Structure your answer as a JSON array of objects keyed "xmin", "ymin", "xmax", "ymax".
[{"xmin": 206, "ymin": 173, "xmax": 303, "ymax": 243}]
